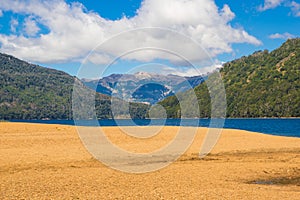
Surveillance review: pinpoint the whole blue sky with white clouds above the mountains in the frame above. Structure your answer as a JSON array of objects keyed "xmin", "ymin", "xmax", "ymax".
[{"xmin": 0, "ymin": 0, "xmax": 300, "ymax": 78}]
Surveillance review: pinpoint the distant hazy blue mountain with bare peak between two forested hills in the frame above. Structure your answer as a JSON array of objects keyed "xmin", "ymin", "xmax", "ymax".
[{"xmin": 82, "ymin": 72, "xmax": 204, "ymax": 104}]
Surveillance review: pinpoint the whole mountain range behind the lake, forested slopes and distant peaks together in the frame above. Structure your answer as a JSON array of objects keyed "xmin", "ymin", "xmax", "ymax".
[{"xmin": 0, "ymin": 38, "xmax": 300, "ymax": 120}]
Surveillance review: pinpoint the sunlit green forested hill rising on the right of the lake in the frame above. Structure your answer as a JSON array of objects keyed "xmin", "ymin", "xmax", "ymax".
[{"xmin": 159, "ymin": 38, "xmax": 300, "ymax": 118}]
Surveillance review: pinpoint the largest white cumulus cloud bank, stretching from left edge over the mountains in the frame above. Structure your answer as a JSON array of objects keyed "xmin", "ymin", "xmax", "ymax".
[{"xmin": 0, "ymin": 0, "xmax": 261, "ymax": 63}]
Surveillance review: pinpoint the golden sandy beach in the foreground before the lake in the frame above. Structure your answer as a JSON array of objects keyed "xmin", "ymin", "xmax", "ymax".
[{"xmin": 0, "ymin": 122, "xmax": 300, "ymax": 199}]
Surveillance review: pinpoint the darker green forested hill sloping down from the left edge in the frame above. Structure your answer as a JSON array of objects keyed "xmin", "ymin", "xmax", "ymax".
[{"xmin": 0, "ymin": 53, "xmax": 148, "ymax": 120}]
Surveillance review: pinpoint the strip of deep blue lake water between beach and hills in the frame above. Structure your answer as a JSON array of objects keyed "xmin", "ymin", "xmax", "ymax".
[{"xmin": 11, "ymin": 118, "xmax": 300, "ymax": 138}]
